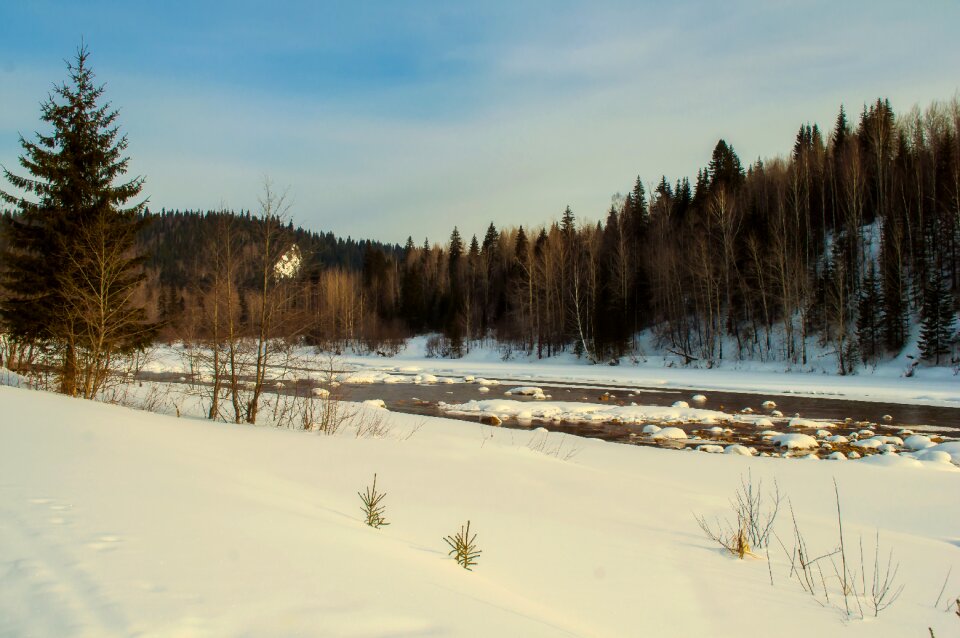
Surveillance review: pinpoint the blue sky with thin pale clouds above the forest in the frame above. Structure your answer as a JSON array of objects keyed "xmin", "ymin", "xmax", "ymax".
[{"xmin": 0, "ymin": 0, "xmax": 960, "ymax": 244}]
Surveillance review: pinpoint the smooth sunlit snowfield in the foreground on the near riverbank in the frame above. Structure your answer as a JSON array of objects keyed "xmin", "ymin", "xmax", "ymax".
[{"xmin": 0, "ymin": 382, "xmax": 960, "ymax": 638}]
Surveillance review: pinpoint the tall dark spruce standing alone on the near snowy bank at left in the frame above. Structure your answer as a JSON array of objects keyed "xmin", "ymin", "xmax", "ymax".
[{"xmin": 0, "ymin": 46, "xmax": 152, "ymax": 398}]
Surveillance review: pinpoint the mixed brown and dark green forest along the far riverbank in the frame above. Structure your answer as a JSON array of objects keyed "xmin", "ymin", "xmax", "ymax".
[{"xmin": 0, "ymin": 52, "xmax": 960, "ymax": 373}]
